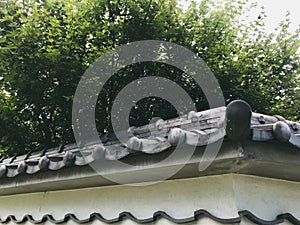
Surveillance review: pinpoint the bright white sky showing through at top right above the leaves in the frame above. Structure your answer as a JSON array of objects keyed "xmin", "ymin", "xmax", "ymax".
[{"xmin": 179, "ymin": 0, "xmax": 300, "ymax": 33}]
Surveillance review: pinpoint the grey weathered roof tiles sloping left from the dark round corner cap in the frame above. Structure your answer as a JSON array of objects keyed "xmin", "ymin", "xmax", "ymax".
[{"xmin": 0, "ymin": 107, "xmax": 225, "ymax": 178}]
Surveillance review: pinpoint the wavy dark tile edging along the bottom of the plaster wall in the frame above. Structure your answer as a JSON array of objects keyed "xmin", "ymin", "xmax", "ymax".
[{"xmin": 0, "ymin": 209, "xmax": 300, "ymax": 225}]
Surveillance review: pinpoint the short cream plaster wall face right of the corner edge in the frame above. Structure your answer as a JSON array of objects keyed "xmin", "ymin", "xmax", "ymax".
[{"xmin": 233, "ymin": 175, "xmax": 300, "ymax": 220}]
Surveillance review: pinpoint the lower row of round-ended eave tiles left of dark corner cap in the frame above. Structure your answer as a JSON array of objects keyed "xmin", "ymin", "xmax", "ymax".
[{"xmin": 0, "ymin": 123, "xmax": 225, "ymax": 178}]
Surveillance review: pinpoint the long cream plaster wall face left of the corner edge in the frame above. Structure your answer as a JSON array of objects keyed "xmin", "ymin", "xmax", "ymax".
[{"xmin": 0, "ymin": 177, "xmax": 238, "ymax": 219}]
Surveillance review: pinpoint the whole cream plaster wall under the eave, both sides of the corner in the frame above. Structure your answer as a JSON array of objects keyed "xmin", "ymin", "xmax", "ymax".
[{"xmin": 0, "ymin": 175, "xmax": 300, "ymax": 225}]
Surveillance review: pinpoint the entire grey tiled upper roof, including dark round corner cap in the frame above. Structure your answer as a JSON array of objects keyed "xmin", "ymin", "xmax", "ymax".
[{"xmin": 0, "ymin": 101, "xmax": 300, "ymax": 178}]
